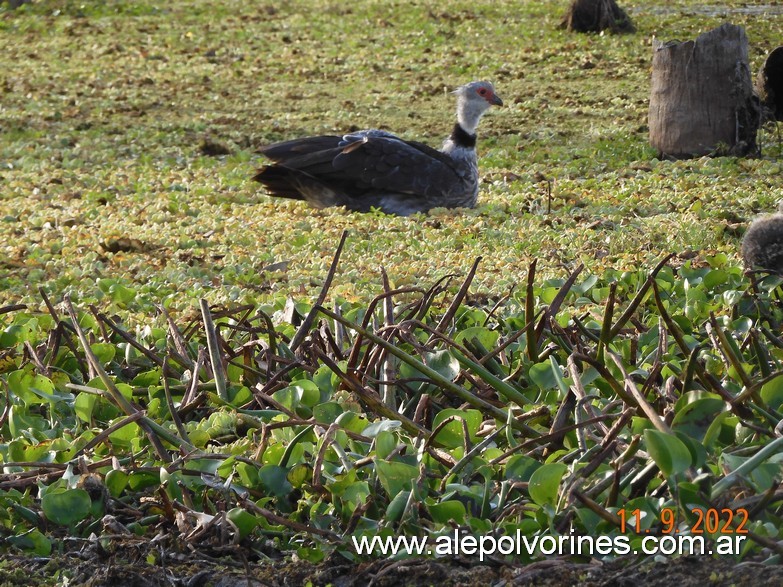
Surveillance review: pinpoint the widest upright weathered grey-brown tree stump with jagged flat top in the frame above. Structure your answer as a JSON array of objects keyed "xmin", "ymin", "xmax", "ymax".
[{"xmin": 649, "ymin": 24, "xmax": 760, "ymax": 159}]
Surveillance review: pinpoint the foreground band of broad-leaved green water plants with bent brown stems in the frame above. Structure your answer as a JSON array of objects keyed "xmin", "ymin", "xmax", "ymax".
[{"xmin": 0, "ymin": 256, "xmax": 783, "ymax": 560}]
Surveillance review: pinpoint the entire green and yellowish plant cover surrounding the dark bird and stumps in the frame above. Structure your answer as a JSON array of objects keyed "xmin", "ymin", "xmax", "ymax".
[{"xmin": 0, "ymin": 0, "xmax": 783, "ymax": 584}]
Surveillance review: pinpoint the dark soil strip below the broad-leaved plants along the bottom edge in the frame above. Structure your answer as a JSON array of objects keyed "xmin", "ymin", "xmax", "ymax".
[{"xmin": 0, "ymin": 547, "xmax": 783, "ymax": 587}]
